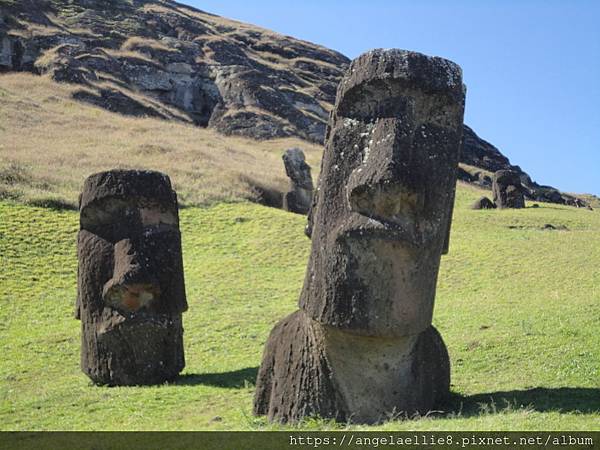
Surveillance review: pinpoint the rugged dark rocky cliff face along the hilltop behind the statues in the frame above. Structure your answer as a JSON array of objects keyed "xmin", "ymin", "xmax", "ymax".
[{"xmin": 0, "ymin": 0, "xmax": 592, "ymax": 203}]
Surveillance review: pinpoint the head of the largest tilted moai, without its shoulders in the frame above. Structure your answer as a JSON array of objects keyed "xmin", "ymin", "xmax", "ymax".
[{"xmin": 300, "ymin": 50, "xmax": 465, "ymax": 336}]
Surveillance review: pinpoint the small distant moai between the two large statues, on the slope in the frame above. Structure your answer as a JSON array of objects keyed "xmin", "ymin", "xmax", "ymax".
[{"xmin": 283, "ymin": 148, "xmax": 313, "ymax": 214}]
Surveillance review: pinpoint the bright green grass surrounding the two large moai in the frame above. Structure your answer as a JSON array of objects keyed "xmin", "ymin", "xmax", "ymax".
[{"xmin": 0, "ymin": 185, "xmax": 600, "ymax": 430}]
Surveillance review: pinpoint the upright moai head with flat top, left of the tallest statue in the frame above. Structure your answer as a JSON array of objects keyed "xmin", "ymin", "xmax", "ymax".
[{"xmin": 76, "ymin": 170, "xmax": 187, "ymax": 385}]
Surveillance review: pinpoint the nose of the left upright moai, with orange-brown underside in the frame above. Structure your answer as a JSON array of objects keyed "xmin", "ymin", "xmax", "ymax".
[{"xmin": 102, "ymin": 239, "xmax": 160, "ymax": 312}]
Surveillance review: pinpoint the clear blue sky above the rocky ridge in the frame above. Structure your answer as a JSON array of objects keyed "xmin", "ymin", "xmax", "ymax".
[{"xmin": 184, "ymin": 0, "xmax": 600, "ymax": 195}]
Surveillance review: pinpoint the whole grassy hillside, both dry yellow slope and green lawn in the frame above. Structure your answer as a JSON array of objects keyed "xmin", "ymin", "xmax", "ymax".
[{"xmin": 0, "ymin": 74, "xmax": 600, "ymax": 430}]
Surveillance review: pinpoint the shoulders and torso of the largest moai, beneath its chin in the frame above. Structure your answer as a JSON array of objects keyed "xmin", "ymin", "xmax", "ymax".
[{"xmin": 254, "ymin": 311, "xmax": 450, "ymax": 424}]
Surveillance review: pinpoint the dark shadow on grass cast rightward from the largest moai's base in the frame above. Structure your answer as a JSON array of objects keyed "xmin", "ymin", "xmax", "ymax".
[{"xmin": 447, "ymin": 387, "xmax": 600, "ymax": 417}]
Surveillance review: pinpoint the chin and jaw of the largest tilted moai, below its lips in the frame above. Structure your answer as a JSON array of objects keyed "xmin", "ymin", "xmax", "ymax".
[{"xmin": 301, "ymin": 225, "xmax": 441, "ymax": 337}]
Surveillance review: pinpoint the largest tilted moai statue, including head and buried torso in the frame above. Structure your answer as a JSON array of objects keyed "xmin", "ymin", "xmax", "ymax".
[{"xmin": 254, "ymin": 50, "xmax": 465, "ymax": 423}]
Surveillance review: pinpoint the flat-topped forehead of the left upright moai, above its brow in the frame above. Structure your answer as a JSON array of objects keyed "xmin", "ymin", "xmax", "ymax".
[{"xmin": 79, "ymin": 169, "xmax": 177, "ymax": 211}]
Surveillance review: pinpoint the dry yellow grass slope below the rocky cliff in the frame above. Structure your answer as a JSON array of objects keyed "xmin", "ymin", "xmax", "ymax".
[{"xmin": 0, "ymin": 73, "xmax": 322, "ymax": 205}]
